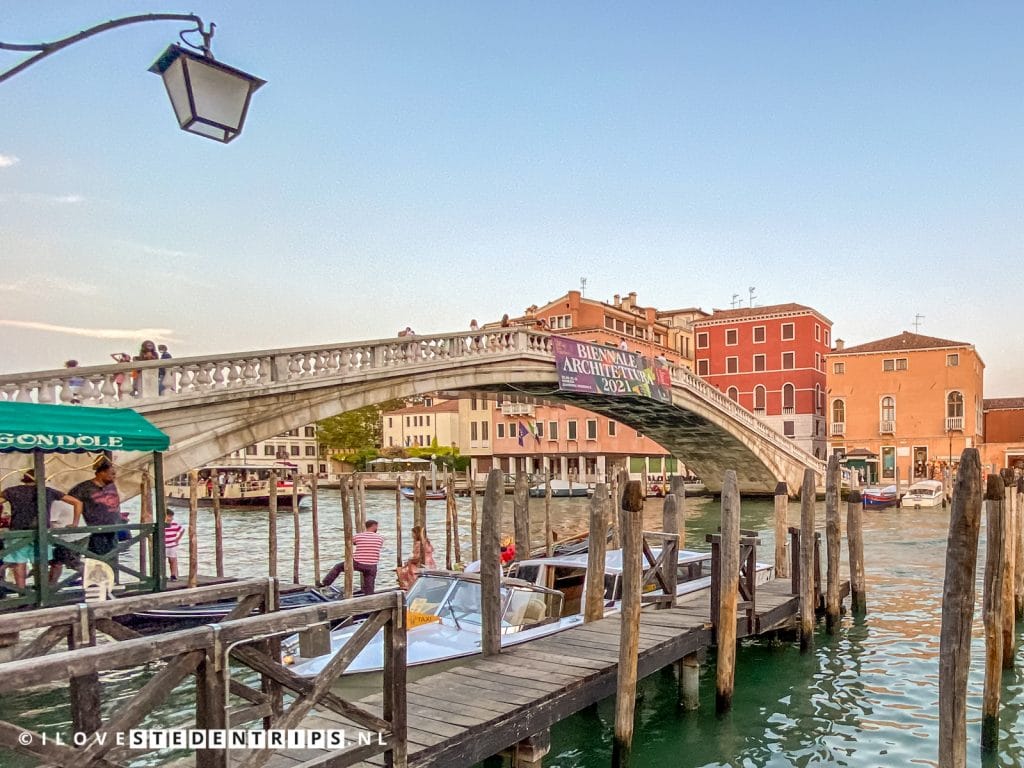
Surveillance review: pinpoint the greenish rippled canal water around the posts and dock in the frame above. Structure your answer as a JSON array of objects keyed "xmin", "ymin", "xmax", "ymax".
[{"xmin": 0, "ymin": 489, "xmax": 1024, "ymax": 768}]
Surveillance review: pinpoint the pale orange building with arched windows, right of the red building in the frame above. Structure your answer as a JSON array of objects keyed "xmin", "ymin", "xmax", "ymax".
[{"xmin": 826, "ymin": 331, "xmax": 985, "ymax": 483}]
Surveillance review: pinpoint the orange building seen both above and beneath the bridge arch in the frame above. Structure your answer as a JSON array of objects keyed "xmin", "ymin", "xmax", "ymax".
[{"xmin": 472, "ymin": 291, "xmax": 707, "ymax": 482}]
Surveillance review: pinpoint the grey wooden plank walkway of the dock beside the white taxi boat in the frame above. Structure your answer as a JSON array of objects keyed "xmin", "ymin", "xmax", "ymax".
[{"xmin": 267, "ymin": 579, "xmax": 849, "ymax": 768}]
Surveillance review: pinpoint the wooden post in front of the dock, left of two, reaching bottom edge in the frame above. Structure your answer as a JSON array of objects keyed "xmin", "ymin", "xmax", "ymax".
[{"xmin": 611, "ymin": 480, "xmax": 644, "ymax": 768}]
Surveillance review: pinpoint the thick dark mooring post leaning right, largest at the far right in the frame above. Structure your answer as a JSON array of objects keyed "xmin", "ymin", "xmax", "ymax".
[{"xmin": 937, "ymin": 449, "xmax": 981, "ymax": 768}]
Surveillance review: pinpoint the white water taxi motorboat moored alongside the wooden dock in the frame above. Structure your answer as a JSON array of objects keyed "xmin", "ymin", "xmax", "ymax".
[{"xmin": 284, "ymin": 548, "xmax": 772, "ymax": 696}]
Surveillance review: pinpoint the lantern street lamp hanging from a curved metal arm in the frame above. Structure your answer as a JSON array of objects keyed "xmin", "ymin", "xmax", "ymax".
[{"xmin": 0, "ymin": 13, "xmax": 266, "ymax": 143}]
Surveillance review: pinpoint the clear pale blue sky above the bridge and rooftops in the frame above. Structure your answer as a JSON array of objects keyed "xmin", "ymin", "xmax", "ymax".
[{"xmin": 0, "ymin": 0, "xmax": 1024, "ymax": 397}]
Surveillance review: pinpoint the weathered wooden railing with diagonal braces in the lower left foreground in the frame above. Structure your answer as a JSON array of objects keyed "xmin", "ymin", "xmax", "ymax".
[{"xmin": 0, "ymin": 580, "xmax": 408, "ymax": 768}]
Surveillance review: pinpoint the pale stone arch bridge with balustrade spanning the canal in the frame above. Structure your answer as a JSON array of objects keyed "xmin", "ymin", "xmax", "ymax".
[{"xmin": 0, "ymin": 328, "xmax": 824, "ymax": 493}]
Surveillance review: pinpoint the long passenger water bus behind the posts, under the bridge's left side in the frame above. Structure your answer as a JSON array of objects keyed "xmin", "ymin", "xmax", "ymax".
[{"xmin": 164, "ymin": 460, "xmax": 312, "ymax": 507}]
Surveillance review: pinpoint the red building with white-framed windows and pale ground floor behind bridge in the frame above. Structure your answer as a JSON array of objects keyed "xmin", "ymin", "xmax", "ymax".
[{"xmin": 693, "ymin": 304, "xmax": 831, "ymax": 458}]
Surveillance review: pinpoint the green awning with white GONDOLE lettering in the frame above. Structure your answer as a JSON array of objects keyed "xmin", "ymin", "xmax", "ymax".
[{"xmin": 0, "ymin": 400, "xmax": 170, "ymax": 454}]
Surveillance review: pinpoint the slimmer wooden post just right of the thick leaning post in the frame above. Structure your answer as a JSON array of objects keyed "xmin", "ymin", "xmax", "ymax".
[{"xmin": 981, "ymin": 475, "xmax": 1006, "ymax": 752}]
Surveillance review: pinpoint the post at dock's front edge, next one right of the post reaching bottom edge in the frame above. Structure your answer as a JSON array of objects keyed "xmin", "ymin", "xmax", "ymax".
[{"xmin": 712, "ymin": 469, "xmax": 739, "ymax": 714}]
